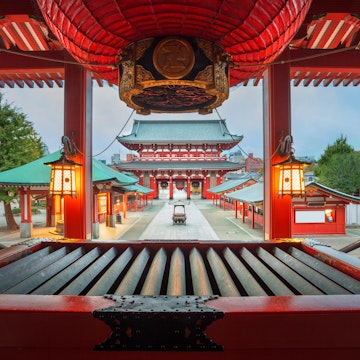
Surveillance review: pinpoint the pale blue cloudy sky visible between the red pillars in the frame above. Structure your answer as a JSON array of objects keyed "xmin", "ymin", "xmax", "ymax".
[{"xmin": 0, "ymin": 85, "xmax": 360, "ymax": 163}]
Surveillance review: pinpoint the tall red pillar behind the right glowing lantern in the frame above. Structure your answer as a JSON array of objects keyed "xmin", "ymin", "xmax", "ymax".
[{"xmin": 263, "ymin": 51, "xmax": 291, "ymax": 240}]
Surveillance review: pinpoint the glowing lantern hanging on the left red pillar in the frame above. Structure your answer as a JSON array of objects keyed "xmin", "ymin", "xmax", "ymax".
[{"xmin": 45, "ymin": 136, "xmax": 82, "ymax": 197}]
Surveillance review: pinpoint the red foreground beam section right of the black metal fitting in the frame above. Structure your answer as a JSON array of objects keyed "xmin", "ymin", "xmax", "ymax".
[{"xmin": 206, "ymin": 295, "xmax": 360, "ymax": 359}]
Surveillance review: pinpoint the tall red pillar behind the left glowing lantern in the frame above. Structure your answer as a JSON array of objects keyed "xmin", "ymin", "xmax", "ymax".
[{"xmin": 63, "ymin": 64, "xmax": 92, "ymax": 239}]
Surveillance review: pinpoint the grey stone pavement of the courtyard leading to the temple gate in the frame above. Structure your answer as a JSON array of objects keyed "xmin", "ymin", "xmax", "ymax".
[{"xmin": 0, "ymin": 195, "xmax": 360, "ymax": 258}]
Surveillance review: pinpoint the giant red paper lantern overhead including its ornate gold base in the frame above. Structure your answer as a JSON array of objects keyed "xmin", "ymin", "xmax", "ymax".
[{"xmin": 37, "ymin": 0, "xmax": 311, "ymax": 115}]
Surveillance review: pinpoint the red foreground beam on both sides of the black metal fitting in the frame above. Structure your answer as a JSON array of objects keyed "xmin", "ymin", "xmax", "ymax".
[{"xmin": 0, "ymin": 295, "xmax": 360, "ymax": 360}]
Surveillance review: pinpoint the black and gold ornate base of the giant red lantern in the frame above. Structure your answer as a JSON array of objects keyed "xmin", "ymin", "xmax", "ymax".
[{"xmin": 119, "ymin": 37, "xmax": 229, "ymax": 115}]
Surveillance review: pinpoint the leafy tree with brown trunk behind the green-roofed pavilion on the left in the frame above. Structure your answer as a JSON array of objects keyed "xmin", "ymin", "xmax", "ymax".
[{"xmin": 0, "ymin": 93, "xmax": 45, "ymax": 230}]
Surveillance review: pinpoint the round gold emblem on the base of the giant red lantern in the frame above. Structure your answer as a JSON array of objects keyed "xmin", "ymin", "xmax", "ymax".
[{"xmin": 153, "ymin": 38, "xmax": 195, "ymax": 79}]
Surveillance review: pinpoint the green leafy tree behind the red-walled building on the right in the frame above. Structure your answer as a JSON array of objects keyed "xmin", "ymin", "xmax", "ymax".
[{"xmin": 314, "ymin": 135, "xmax": 360, "ymax": 194}]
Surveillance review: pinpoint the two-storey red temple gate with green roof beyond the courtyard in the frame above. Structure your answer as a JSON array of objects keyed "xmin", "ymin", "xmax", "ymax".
[{"xmin": 117, "ymin": 119, "xmax": 243, "ymax": 199}]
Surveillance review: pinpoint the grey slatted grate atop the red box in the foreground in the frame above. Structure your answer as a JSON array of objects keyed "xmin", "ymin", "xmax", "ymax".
[{"xmin": 0, "ymin": 243, "xmax": 360, "ymax": 297}]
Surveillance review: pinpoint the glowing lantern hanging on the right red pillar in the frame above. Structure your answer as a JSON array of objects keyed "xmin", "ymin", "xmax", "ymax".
[{"xmin": 273, "ymin": 135, "xmax": 310, "ymax": 197}]
